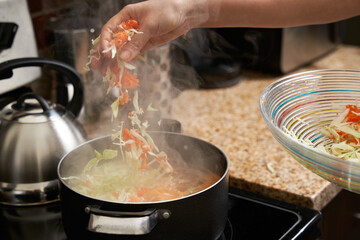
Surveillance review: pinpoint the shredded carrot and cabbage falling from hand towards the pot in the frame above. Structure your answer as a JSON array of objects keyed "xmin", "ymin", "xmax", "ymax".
[{"xmin": 84, "ymin": 19, "xmax": 173, "ymax": 185}]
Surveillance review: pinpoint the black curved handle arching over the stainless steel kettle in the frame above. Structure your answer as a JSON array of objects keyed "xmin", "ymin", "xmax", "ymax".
[{"xmin": 0, "ymin": 58, "xmax": 84, "ymax": 117}]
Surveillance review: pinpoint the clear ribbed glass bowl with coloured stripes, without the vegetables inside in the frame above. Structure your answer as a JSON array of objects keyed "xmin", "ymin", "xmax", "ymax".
[{"xmin": 260, "ymin": 70, "xmax": 360, "ymax": 193}]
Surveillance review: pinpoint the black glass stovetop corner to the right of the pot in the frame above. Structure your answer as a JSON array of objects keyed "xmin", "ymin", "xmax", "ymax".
[{"xmin": 224, "ymin": 189, "xmax": 321, "ymax": 240}]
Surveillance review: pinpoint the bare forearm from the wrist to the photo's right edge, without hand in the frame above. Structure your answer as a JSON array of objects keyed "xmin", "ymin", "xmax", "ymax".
[{"xmin": 190, "ymin": 0, "xmax": 360, "ymax": 28}]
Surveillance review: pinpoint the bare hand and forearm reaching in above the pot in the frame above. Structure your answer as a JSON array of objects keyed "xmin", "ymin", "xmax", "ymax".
[{"xmin": 100, "ymin": 0, "xmax": 360, "ymax": 62}]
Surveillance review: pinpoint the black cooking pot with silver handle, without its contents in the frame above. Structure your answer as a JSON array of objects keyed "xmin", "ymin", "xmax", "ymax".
[{"xmin": 58, "ymin": 132, "xmax": 229, "ymax": 240}]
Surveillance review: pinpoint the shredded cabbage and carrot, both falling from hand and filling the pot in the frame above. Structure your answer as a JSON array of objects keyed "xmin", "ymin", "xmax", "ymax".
[{"xmin": 63, "ymin": 20, "xmax": 219, "ymax": 202}]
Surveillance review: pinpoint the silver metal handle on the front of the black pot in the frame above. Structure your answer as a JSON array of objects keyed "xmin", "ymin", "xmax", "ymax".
[{"xmin": 85, "ymin": 206, "xmax": 171, "ymax": 235}]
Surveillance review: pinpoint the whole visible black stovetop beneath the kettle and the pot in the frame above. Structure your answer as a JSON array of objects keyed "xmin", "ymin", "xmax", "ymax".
[{"xmin": 0, "ymin": 188, "xmax": 321, "ymax": 240}]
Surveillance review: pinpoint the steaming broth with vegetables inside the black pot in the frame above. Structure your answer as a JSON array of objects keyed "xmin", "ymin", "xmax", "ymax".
[{"xmin": 63, "ymin": 135, "xmax": 220, "ymax": 202}]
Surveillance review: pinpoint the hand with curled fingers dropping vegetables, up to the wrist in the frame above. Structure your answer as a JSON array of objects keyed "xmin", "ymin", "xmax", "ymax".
[{"xmin": 100, "ymin": 0, "xmax": 188, "ymax": 62}]
